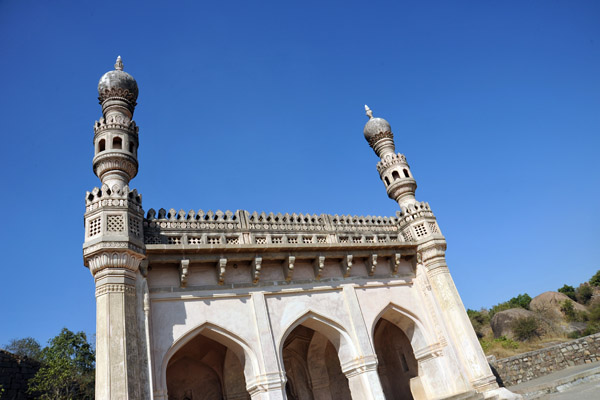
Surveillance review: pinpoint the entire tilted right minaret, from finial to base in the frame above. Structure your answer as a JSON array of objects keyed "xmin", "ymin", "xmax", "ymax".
[{"xmin": 364, "ymin": 106, "xmax": 504, "ymax": 398}]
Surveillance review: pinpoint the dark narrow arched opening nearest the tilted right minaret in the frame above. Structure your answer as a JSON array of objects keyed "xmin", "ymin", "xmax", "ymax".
[{"xmin": 373, "ymin": 318, "xmax": 418, "ymax": 400}]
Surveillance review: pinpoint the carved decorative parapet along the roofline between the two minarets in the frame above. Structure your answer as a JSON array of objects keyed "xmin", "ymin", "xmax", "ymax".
[{"xmin": 144, "ymin": 208, "xmax": 404, "ymax": 245}]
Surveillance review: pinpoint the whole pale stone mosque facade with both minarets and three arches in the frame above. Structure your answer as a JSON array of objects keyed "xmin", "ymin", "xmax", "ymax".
[{"xmin": 83, "ymin": 57, "xmax": 519, "ymax": 400}]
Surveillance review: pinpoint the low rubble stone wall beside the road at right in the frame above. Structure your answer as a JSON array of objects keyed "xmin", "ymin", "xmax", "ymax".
[{"xmin": 490, "ymin": 333, "xmax": 600, "ymax": 386}]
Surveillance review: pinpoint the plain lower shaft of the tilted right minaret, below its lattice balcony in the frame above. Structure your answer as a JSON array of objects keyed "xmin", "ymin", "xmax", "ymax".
[{"xmin": 417, "ymin": 239, "xmax": 498, "ymax": 392}]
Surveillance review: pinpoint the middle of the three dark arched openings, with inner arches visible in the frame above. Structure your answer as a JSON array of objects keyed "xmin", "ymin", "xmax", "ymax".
[{"xmin": 283, "ymin": 325, "xmax": 352, "ymax": 400}]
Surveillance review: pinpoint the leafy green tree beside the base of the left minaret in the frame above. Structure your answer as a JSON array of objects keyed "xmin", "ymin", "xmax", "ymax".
[{"xmin": 28, "ymin": 328, "xmax": 95, "ymax": 400}]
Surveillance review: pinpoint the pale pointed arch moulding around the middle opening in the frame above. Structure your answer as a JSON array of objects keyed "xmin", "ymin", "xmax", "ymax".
[{"xmin": 277, "ymin": 310, "xmax": 357, "ymax": 365}]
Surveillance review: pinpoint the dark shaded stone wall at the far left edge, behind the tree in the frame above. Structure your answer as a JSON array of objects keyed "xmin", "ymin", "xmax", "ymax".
[{"xmin": 0, "ymin": 349, "xmax": 40, "ymax": 400}]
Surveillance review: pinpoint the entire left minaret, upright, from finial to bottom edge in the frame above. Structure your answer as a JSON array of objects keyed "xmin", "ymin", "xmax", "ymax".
[{"xmin": 83, "ymin": 57, "xmax": 147, "ymax": 399}]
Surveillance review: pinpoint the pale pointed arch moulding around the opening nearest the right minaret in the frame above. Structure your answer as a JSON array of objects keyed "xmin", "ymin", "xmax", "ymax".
[{"xmin": 371, "ymin": 302, "xmax": 433, "ymax": 351}]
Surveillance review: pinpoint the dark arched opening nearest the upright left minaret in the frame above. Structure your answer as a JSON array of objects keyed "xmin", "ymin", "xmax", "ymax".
[{"xmin": 166, "ymin": 334, "xmax": 250, "ymax": 400}]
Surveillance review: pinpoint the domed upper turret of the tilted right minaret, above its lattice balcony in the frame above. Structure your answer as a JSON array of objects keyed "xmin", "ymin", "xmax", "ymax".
[{"xmin": 364, "ymin": 105, "xmax": 417, "ymax": 209}]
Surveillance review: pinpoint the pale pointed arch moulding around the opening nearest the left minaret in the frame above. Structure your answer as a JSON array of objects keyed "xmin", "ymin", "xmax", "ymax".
[{"xmin": 157, "ymin": 322, "xmax": 259, "ymax": 390}]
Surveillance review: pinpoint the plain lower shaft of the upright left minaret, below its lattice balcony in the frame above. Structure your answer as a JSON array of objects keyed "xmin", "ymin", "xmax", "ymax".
[{"xmin": 89, "ymin": 253, "xmax": 142, "ymax": 400}]
